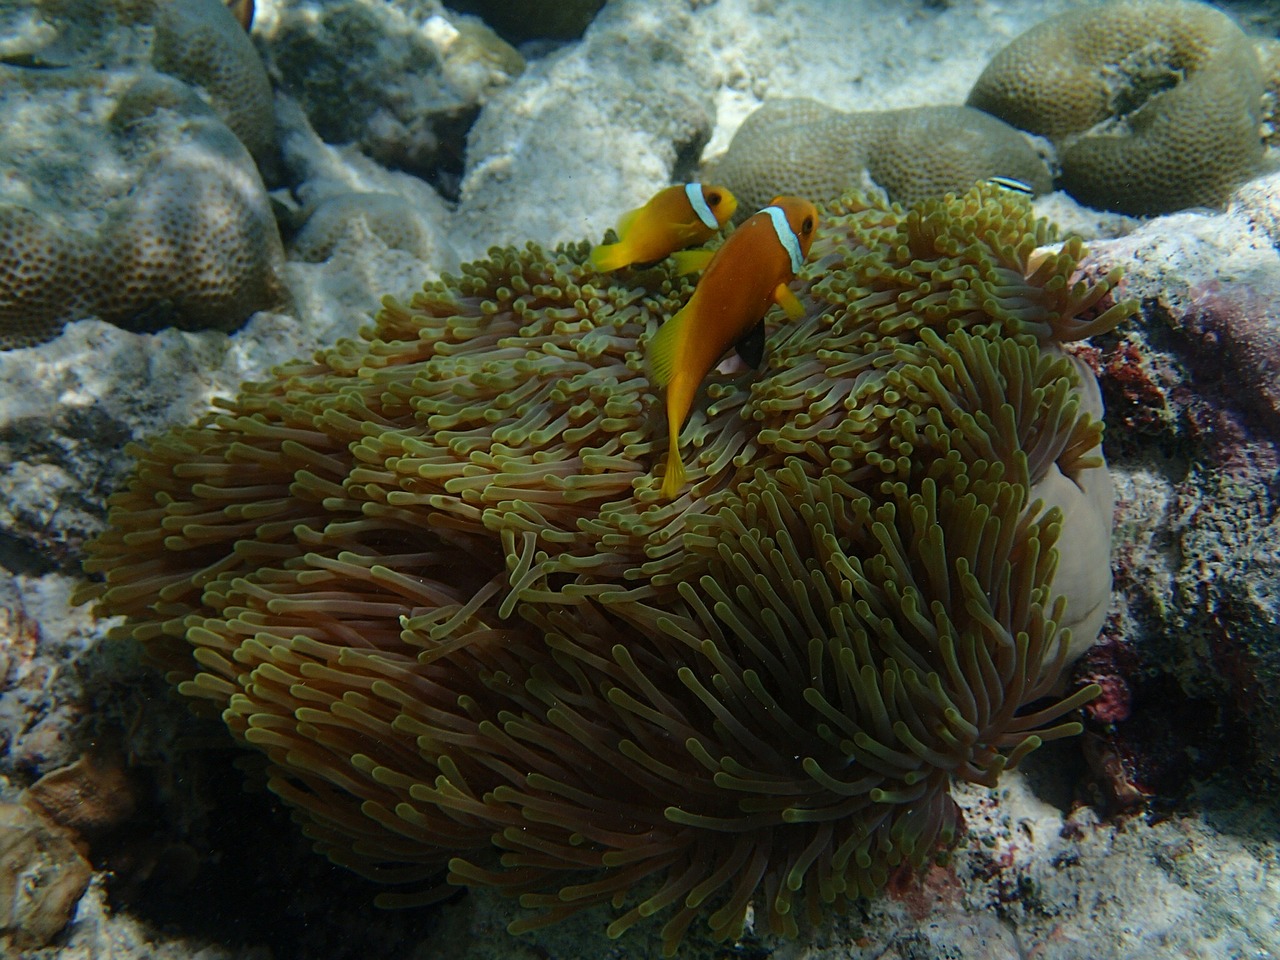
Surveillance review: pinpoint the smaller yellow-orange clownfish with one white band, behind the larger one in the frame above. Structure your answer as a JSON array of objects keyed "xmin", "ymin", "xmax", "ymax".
[{"xmin": 591, "ymin": 183, "xmax": 737, "ymax": 273}]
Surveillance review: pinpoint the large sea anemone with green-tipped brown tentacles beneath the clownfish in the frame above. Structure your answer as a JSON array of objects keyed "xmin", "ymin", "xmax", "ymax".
[{"xmin": 84, "ymin": 187, "xmax": 1133, "ymax": 952}]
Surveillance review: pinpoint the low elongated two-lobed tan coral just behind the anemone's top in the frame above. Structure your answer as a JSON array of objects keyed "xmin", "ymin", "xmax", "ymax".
[{"xmin": 704, "ymin": 97, "xmax": 1051, "ymax": 215}]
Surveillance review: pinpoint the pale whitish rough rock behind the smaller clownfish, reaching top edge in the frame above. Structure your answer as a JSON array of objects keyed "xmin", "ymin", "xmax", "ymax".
[{"xmin": 451, "ymin": 0, "xmax": 716, "ymax": 260}]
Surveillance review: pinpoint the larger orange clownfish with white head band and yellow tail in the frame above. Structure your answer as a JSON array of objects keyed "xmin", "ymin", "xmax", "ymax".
[{"xmin": 646, "ymin": 197, "xmax": 818, "ymax": 499}]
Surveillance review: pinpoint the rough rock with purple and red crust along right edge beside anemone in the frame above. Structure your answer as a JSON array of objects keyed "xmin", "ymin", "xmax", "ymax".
[{"xmin": 1097, "ymin": 207, "xmax": 1280, "ymax": 795}]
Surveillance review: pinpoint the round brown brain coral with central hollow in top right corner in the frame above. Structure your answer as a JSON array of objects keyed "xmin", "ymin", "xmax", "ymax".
[{"xmin": 968, "ymin": 0, "xmax": 1263, "ymax": 214}]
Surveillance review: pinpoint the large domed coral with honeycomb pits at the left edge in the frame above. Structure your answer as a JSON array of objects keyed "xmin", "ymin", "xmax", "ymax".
[{"xmin": 0, "ymin": 70, "xmax": 284, "ymax": 349}]
